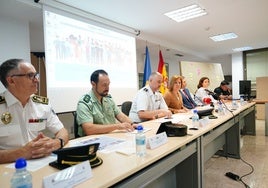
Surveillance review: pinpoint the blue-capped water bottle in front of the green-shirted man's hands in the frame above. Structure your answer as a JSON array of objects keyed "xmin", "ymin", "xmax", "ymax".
[{"xmin": 136, "ymin": 125, "xmax": 146, "ymax": 157}]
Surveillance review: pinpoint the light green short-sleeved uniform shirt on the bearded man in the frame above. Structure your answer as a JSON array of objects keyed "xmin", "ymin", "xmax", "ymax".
[{"xmin": 76, "ymin": 90, "xmax": 121, "ymax": 136}]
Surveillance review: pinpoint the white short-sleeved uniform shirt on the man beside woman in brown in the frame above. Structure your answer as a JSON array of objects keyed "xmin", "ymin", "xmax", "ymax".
[{"xmin": 129, "ymin": 86, "xmax": 168, "ymax": 122}]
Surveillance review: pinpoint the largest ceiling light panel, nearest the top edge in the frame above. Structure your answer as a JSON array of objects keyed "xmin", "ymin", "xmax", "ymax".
[{"xmin": 164, "ymin": 4, "xmax": 207, "ymax": 22}]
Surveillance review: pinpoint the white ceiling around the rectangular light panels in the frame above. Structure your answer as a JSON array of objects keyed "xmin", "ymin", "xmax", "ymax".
[{"xmin": 0, "ymin": 0, "xmax": 268, "ymax": 60}]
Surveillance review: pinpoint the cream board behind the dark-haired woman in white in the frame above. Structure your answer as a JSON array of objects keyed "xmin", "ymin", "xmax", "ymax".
[{"xmin": 180, "ymin": 61, "xmax": 224, "ymax": 93}]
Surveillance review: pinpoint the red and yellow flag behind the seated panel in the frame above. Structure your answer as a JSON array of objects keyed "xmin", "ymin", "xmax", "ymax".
[{"xmin": 157, "ymin": 50, "xmax": 168, "ymax": 94}]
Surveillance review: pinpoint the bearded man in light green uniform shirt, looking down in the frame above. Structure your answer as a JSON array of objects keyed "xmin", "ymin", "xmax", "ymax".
[{"xmin": 76, "ymin": 70, "xmax": 134, "ymax": 136}]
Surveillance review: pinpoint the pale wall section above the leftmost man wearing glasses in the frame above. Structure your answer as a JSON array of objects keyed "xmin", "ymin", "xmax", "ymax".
[{"xmin": 0, "ymin": 16, "xmax": 31, "ymax": 92}]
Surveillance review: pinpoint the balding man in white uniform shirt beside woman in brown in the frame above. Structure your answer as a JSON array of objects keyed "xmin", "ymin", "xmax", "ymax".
[{"xmin": 129, "ymin": 72, "xmax": 172, "ymax": 123}]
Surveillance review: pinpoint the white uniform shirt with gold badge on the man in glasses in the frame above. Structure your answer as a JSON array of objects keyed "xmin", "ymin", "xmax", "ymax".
[{"xmin": 0, "ymin": 90, "xmax": 63, "ymax": 149}]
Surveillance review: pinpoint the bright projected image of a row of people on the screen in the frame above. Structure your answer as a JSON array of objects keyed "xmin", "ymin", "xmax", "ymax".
[{"xmin": 45, "ymin": 11, "xmax": 136, "ymax": 87}]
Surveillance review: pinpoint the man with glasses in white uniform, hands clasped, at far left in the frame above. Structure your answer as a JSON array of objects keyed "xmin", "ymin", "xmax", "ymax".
[{"xmin": 0, "ymin": 59, "xmax": 68, "ymax": 163}]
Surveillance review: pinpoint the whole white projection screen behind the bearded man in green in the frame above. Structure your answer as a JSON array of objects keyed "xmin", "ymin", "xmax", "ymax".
[{"xmin": 43, "ymin": 9, "xmax": 138, "ymax": 112}]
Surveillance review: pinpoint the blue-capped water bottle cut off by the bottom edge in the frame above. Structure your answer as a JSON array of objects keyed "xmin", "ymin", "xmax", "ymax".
[{"xmin": 10, "ymin": 158, "xmax": 32, "ymax": 188}]
